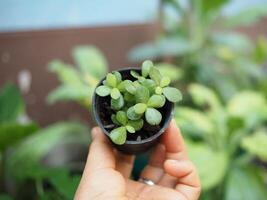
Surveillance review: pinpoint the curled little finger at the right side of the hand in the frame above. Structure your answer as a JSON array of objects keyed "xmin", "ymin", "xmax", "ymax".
[{"xmin": 164, "ymin": 160, "xmax": 201, "ymax": 200}]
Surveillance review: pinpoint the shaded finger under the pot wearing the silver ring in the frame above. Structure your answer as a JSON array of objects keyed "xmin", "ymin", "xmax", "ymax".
[{"xmin": 140, "ymin": 144, "xmax": 165, "ymax": 183}]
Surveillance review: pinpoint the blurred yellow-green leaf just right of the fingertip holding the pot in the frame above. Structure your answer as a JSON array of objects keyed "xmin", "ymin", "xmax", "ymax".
[{"xmin": 175, "ymin": 106, "xmax": 215, "ymax": 138}]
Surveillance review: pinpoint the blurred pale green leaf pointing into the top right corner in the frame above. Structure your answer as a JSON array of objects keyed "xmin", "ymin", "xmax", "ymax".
[{"xmin": 224, "ymin": 4, "xmax": 267, "ymax": 27}]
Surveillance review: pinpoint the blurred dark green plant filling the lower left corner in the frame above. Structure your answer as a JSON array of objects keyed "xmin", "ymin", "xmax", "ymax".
[{"xmin": 0, "ymin": 84, "xmax": 89, "ymax": 199}]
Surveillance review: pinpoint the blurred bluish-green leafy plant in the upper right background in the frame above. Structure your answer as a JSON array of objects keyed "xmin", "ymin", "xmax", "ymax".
[{"xmin": 129, "ymin": 0, "xmax": 267, "ymax": 101}]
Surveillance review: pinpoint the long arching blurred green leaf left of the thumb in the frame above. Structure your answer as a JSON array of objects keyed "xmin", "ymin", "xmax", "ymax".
[{"xmin": 6, "ymin": 122, "xmax": 89, "ymax": 179}]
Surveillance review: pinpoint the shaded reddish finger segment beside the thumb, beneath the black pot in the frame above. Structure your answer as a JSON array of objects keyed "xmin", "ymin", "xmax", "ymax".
[{"xmin": 115, "ymin": 151, "xmax": 135, "ymax": 178}]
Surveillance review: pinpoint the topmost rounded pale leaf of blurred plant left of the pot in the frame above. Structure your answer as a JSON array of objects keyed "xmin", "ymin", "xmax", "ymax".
[{"xmin": 72, "ymin": 46, "xmax": 108, "ymax": 78}]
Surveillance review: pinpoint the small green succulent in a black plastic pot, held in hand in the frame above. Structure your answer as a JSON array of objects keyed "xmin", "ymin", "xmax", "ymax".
[{"xmin": 93, "ymin": 60, "xmax": 182, "ymax": 154}]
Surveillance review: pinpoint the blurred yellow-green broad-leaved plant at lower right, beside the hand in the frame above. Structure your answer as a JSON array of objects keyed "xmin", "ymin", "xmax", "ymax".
[{"xmin": 175, "ymin": 84, "xmax": 267, "ymax": 200}]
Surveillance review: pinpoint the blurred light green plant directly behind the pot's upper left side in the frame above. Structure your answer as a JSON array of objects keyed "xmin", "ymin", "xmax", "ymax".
[{"xmin": 47, "ymin": 46, "xmax": 108, "ymax": 108}]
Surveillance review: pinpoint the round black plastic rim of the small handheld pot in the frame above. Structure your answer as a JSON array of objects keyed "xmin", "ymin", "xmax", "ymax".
[{"xmin": 92, "ymin": 67, "xmax": 174, "ymax": 145}]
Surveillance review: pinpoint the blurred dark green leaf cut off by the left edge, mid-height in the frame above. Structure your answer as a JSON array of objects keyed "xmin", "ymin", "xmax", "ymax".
[{"xmin": 0, "ymin": 84, "xmax": 25, "ymax": 122}]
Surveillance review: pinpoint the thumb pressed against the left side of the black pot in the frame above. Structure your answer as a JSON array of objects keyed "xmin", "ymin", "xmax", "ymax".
[{"xmin": 85, "ymin": 127, "xmax": 115, "ymax": 172}]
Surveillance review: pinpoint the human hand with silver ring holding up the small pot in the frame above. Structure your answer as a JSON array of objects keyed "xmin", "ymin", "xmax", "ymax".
[{"xmin": 75, "ymin": 120, "xmax": 201, "ymax": 200}]
